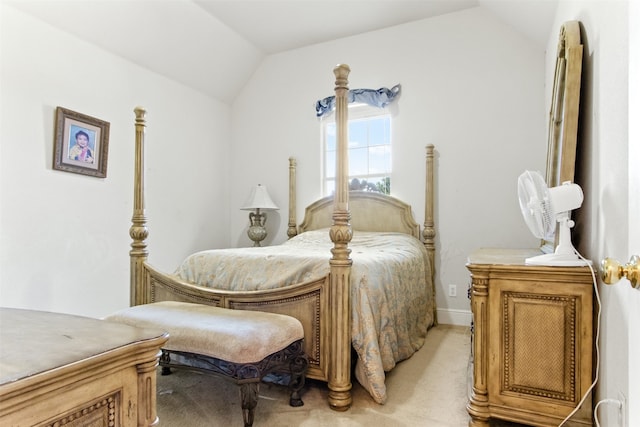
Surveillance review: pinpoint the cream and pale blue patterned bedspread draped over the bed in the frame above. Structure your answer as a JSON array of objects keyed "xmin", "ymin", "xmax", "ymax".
[{"xmin": 175, "ymin": 229, "xmax": 435, "ymax": 404}]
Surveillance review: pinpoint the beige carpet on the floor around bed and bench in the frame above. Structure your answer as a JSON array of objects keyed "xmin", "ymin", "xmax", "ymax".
[{"xmin": 157, "ymin": 325, "xmax": 520, "ymax": 427}]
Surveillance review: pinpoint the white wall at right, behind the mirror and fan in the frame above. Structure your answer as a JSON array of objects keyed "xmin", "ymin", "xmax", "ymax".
[{"xmin": 549, "ymin": 1, "xmax": 640, "ymax": 426}]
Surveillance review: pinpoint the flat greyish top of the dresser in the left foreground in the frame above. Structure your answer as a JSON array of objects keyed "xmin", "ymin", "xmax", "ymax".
[{"xmin": 0, "ymin": 307, "xmax": 166, "ymax": 385}]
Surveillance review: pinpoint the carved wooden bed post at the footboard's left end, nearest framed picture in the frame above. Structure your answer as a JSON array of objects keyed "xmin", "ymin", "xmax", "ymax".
[{"xmin": 129, "ymin": 107, "xmax": 149, "ymax": 305}]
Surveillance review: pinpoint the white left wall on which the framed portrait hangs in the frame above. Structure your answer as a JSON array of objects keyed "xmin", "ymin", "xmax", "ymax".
[{"xmin": 0, "ymin": 2, "xmax": 230, "ymax": 317}]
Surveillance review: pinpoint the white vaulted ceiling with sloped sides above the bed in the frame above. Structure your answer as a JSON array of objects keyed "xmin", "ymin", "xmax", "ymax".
[{"xmin": 6, "ymin": 0, "xmax": 558, "ymax": 103}]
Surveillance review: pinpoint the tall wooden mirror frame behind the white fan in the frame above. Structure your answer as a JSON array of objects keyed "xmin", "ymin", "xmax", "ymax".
[{"xmin": 541, "ymin": 21, "xmax": 583, "ymax": 253}]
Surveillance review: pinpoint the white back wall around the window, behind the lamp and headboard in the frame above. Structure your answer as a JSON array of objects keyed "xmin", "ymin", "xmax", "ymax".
[{"xmin": 231, "ymin": 8, "xmax": 547, "ymax": 324}]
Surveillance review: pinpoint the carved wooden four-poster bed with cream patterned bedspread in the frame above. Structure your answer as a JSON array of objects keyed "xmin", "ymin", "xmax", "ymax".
[{"xmin": 130, "ymin": 65, "xmax": 437, "ymax": 410}]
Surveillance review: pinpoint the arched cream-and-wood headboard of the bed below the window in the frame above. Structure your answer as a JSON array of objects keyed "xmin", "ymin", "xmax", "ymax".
[{"xmin": 298, "ymin": 191, "xmax": 420, "ymax": 239}]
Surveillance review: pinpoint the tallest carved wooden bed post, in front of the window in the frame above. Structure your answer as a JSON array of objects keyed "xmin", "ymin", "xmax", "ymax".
[{"xmin": 328, "ymin": 64, "xmax": 352, "ymax": 411}]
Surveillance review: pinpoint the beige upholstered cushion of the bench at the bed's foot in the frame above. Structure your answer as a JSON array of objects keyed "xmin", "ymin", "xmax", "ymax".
[{"xmin": 105, "ymin": 301, "xmax": 304, "ymax": 363}]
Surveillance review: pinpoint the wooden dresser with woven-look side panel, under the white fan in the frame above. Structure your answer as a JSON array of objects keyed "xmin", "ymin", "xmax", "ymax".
[{"xmin": 467, "ymin": 249, "xmax": 593, "ymax": 427}]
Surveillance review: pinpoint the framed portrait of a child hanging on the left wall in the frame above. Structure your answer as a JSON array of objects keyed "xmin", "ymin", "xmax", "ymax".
[{"xmin": 53, "ymin": 107, "xmax": 109, "ymax": 178}]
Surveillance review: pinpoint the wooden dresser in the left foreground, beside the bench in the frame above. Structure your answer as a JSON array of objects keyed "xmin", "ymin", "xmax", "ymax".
[{"xmin": 0, "ymin": 308, "xmax": 167, "ymax": 427}]
